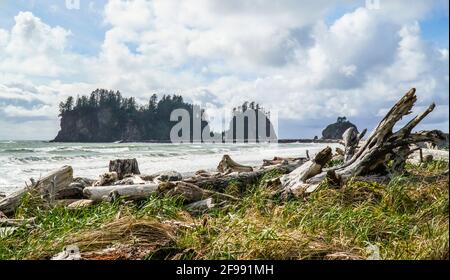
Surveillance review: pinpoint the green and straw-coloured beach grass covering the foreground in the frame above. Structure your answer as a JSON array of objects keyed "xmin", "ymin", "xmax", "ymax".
[{"xmin": 0, "ymin": 161, "xmax": 449, "ymax": 260}]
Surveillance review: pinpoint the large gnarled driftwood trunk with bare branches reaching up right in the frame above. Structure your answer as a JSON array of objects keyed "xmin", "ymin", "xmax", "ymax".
[{"xmin": 282, "ymin": 88, "xmax": 445, "ymax": 197}]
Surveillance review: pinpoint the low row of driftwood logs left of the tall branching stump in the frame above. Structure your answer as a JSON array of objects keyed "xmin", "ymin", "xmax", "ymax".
[{"xmin": 0, "ymin": 155, "xmax": 307, "ymax": 220}]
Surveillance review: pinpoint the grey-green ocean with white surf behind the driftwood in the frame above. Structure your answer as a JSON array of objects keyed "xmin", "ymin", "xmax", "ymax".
[{"xmin": 0, "ymin": 141, "xmax": 337, "ymax": 194}]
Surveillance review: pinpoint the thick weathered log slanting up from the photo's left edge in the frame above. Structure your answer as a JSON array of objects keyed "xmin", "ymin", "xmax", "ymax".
[{"xmin": 0, "ymin": 166, "xmax": 73, "ymax": 215}]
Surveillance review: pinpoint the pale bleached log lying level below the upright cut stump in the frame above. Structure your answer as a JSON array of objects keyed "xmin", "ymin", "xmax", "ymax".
[{"xmin": 83, "ymin": 183, "xmax": 158, "ymax": 201}]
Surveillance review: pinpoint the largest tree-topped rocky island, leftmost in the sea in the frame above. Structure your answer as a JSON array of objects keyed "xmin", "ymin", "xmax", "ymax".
[{"xmin": 53, "ymin": 89, "xmax": 207, "ymax": 142}]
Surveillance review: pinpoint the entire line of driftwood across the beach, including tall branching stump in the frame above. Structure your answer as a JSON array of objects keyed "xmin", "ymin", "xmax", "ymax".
[{"xmin": 0, "ymin": 89, "xmax": 448, "ymax": 231}]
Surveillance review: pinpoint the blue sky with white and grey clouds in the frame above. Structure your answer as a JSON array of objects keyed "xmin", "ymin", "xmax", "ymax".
[{"xmin": 0, "ymin": 0, "xmax": 449, "ymax": 140}]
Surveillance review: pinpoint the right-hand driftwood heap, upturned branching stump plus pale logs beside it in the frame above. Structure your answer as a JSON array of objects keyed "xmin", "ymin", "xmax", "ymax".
[{"xmin": 278, "ymin": 88, "xmax": 448, "ymax": 196}]
